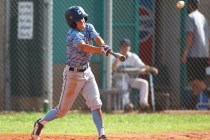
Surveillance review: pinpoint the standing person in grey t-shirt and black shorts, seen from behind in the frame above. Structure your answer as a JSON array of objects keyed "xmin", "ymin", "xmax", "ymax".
[{"xmin": 182, "ymin": 0, "xmax": 210, "ymax": 109}]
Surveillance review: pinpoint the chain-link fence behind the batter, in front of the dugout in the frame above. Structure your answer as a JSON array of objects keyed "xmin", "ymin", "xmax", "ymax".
[{"xmin": 0, "ymin": 0, "xmax": 210, "ymax": 111}]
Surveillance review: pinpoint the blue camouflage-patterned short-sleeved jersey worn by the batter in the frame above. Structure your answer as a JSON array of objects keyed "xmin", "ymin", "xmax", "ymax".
[{"xmin": 66, "ymin": 23, "xmax": 99, "ymax": 67}]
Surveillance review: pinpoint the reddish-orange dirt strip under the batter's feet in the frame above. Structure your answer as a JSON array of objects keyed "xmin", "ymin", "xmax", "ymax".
[{"xmin": 0, "ymin": 132, "xmax": 210, "ymax": 140}]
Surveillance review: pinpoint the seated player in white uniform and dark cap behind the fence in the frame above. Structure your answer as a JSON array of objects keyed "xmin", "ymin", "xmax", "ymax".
[{"xmin": 112, "ymin": 39, "xmax": 158, "ymax": 110}]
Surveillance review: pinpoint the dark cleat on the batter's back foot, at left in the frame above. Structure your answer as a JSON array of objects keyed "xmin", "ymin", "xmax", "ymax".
[{"xmin": 31, "ymin": 119, "xmax": 44, "ymax": 140}]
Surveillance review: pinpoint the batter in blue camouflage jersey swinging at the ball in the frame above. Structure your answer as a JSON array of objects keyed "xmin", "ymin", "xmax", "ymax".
[{"xmin": 32, "ymin": 6, "xmax": 111, "ymax": 140}]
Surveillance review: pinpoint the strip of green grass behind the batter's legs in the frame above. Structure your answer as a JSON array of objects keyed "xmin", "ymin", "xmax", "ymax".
[{"xmin": 0, "ymin": 112, "xmax": 210, "ymax": 135}]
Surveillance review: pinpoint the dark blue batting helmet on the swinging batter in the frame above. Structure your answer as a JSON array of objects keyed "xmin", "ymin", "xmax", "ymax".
[{"xmin": 65, "ymin": 6, "xmax": 88, "ymax": 28}]
